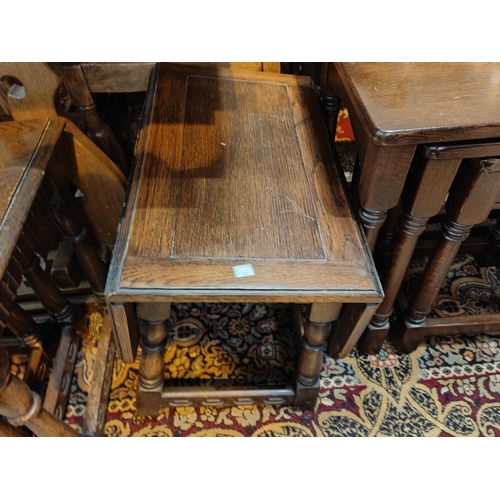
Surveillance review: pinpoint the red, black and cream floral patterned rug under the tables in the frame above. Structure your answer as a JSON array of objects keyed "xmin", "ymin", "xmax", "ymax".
[{"xmin": 66, "ymin": 255, "xmax": 500, "ymax": 436}]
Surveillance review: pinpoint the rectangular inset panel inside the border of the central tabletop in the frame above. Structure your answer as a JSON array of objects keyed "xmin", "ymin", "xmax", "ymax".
[{"xmin": 176, "ymin": 77, "xmax": 325, "ymax": 260}]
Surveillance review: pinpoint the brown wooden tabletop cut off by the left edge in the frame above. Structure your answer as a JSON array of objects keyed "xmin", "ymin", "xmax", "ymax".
[{"xmin": 0, "ymin": 119, "xmax": 64, "ymax": 278}]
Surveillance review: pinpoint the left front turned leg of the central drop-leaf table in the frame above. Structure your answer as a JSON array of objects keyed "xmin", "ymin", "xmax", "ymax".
[{"xmin": 137, "ymin": 303, "xmax": 170, "ymax": 415}]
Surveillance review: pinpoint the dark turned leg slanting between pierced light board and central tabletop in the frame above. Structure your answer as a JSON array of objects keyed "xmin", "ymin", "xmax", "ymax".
[{"xmin": 64, "ymin": 64, "xmax": 128, "ymax": 175}]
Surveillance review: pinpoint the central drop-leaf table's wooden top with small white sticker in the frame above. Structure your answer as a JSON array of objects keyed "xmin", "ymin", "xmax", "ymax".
[{"xmin": 107, "ymin": 65, "xmax": 382, "ymax": 302}]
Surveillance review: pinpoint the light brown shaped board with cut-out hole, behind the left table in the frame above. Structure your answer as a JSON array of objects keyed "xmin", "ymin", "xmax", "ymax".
[{"xmin": 0, "ymin": 63, "xmax": 126, "ymax": 247}]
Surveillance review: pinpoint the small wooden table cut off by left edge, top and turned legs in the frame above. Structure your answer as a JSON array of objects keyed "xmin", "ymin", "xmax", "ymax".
[{"xmin": 0, "ymin": 120, "xmax": 80, "ymax": 436}]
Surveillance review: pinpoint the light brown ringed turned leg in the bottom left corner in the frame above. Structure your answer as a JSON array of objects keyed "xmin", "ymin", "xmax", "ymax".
[{"xmin": 0, "ymin": 349, "xmax": 79, "ymax": 437}]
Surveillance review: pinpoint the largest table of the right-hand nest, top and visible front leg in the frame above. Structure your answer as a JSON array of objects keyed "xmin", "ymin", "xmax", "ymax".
[{"xmin": 328, "ymin": 63, "xmax": 500, "ymax": 250}]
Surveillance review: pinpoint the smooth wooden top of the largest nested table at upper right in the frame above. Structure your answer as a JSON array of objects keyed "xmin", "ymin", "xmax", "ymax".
[{"xmin": 335, "ymin": 63, "xmax": 500, "ymax": 146}]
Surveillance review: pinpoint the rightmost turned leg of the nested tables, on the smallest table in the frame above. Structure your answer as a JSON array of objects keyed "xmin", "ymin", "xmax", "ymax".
[{"xmin": 393, "ymin": 159, "xmax": 500, "ymax": 352}]
